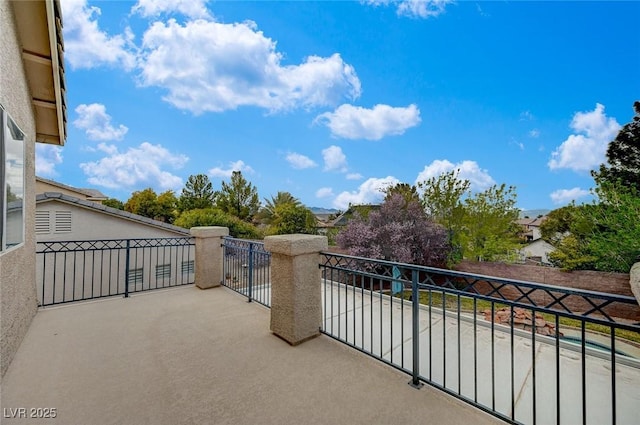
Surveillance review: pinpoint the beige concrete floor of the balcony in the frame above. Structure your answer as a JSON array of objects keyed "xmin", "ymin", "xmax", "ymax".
[{"xmin": 0, "ymin": 286, "xmax": 501, "ymax": 425}]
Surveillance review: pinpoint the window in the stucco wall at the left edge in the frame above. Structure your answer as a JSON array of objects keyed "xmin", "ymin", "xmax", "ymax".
[{"xmin": 0, "ymin": 107, "xmax": 25, "ymax": 251}]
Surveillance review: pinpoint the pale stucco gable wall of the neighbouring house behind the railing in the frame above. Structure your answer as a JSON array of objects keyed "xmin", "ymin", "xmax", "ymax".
[{"xmin": 36, "ymin": 200, "xmax": 195, "ymax": 305}]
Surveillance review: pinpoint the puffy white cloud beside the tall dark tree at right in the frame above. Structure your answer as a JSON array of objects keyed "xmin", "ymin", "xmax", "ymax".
[{"xmin": 548, "ymin": 103, "xmax": 620, "ymax": 172}]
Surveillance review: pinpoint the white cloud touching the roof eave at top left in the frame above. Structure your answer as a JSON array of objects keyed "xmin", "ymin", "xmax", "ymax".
[{"xmin": 61, "ymin": 0, "xmax": 136, "ymax": 70}]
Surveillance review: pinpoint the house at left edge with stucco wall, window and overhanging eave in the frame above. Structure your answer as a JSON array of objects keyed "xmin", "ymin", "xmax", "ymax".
[{"xmin": 0, "ymin": 0, "xmax": 67, "ymax": 377}]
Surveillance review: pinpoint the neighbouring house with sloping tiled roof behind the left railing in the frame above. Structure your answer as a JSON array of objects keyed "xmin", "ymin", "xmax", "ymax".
[{"xmin": 35, "ymin": 192, "xmax": 195, "ymax": 305}]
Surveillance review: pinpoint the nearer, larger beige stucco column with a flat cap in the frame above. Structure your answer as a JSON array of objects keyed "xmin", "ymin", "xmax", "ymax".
[{"xmin": 264, "ymin": 235, "xmax": 328, "ymax": 345}]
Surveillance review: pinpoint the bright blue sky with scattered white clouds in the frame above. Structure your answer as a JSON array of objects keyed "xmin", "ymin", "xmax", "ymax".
[{"xmin": 36, "ymin": 0, "xmax": 640, "ymax": 209}]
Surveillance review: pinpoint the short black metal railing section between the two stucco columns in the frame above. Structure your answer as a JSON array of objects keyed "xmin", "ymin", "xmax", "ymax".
[{"xmin": 222, "ymin": 237, "xmax": 271, "ymax": 307}]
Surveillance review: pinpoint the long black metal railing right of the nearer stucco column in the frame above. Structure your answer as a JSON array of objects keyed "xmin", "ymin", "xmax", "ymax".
[{"xmin": 320, "ymin": 253, "xmax": 640, "ymax": 424}]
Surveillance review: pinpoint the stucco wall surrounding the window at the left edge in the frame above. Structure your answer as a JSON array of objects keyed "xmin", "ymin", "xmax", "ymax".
[{"xmin": 0, "ymin": 0, "xmax": 37, "ymax": 377}]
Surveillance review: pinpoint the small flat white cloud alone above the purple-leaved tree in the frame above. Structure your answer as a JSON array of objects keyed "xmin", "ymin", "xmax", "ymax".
[{"xmin": 314, "ymin": 104, "xmax": 421, "ymax": 140}]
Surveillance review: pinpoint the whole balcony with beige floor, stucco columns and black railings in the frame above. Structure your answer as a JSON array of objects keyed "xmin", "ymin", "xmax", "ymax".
[{"xmin": 2, "ymin": 234, "xmax": 640, "ymax": 424}]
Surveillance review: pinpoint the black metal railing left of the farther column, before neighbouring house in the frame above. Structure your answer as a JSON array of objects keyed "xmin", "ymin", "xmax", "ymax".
[{"xmin": 36, "ymin": 237, "xmax": 195, "ymax": 306}]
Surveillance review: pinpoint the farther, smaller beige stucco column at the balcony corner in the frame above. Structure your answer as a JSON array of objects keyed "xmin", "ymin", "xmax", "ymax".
[{"xmin": 191, "ymin": 226, "xmax": 229, "ymax": 289}]
